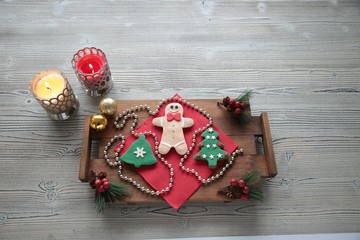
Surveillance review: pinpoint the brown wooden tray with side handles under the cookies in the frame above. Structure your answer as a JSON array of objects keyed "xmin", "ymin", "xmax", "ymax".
[{"xmin": 79, "ymin": 99, "xmax": 277, "ymax": 204}]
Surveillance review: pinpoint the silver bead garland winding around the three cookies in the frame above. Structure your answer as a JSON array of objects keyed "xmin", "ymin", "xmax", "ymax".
[{"xmin": 104, "ymin": 97, "xmax": 243, "ymax": 195}]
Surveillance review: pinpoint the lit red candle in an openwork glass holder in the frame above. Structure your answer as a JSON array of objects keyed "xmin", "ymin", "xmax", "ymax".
[{"xmin": 71, "ymin": 47, "xmax": 113, "ymax": 97}]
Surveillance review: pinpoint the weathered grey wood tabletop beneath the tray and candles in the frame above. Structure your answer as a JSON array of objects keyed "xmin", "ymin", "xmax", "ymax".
[{"xmin": 0, "ymin": 0, "xmax": 360, "ymax": 239}]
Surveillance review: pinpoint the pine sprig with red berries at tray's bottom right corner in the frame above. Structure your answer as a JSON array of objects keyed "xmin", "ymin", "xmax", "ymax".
[{"xmin": 218, "ymin": 170, "xmax": 263, "ymax": 201}]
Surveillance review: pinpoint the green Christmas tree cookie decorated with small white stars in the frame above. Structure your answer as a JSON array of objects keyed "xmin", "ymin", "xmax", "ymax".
[{"xmin": 194, "ymin": 127, "xmax": 230, "ymax": 168}]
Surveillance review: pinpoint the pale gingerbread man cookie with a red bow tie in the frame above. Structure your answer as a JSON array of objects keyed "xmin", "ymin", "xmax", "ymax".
[{"xmin": 152, "ymin": 103, "xmax": 194, "ymax": 155}]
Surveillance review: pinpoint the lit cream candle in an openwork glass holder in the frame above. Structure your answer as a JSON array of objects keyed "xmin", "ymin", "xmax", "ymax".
[{"xmin": 30, "ymin": 70, "xmax": 80, "ymax": 120}]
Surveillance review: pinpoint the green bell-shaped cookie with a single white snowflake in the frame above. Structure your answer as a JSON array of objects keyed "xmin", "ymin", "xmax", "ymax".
[{"xmin": 120, "ymin": 134, "xmax": 157, "ymax": 167}]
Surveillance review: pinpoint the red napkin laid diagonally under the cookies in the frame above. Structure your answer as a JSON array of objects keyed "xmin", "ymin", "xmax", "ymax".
[{"xmin": 115, "ymin": 94, "xmax": 238, "ymax": 209}]
